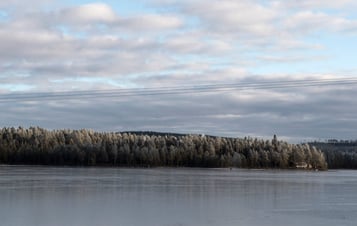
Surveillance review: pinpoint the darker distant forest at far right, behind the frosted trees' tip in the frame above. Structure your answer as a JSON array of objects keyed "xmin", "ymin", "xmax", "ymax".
[{"xmin": 309, "ymin": 139, "xmax": 357, "ymax": 169}]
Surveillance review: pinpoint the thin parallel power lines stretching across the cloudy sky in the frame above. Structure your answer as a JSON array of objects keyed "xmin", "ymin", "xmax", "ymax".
[{"xmin": 0, "ymin": 78, "xmax": 357, "ymax": 103}]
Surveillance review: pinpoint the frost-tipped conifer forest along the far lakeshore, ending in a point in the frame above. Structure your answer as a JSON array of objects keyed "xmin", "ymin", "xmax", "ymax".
[{"xmin": 0, "ymin": 127, "xmax": 327, "ymax": 169}]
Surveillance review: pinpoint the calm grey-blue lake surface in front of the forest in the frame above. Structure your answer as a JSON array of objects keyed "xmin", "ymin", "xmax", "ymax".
[{"xmin": 0, "ymin": 166, "xmax": 357, "ymax": 226}]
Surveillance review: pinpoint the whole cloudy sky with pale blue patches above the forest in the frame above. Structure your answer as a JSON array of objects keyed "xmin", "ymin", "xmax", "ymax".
[{"xmin": 0, "ymin": 0, "xmax": 357, "ymax": 142}]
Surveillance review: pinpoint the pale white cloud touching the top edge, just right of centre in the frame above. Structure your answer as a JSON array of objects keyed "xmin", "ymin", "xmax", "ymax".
[{"xmin": 183, "ymin": 0, "xmax": 276, "ymax": 36}]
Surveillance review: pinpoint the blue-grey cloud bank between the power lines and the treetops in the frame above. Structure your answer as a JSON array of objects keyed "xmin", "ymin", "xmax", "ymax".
[{"xmin": 0, "ymin": 78, "xmax": 357, "ymax": 142}]
